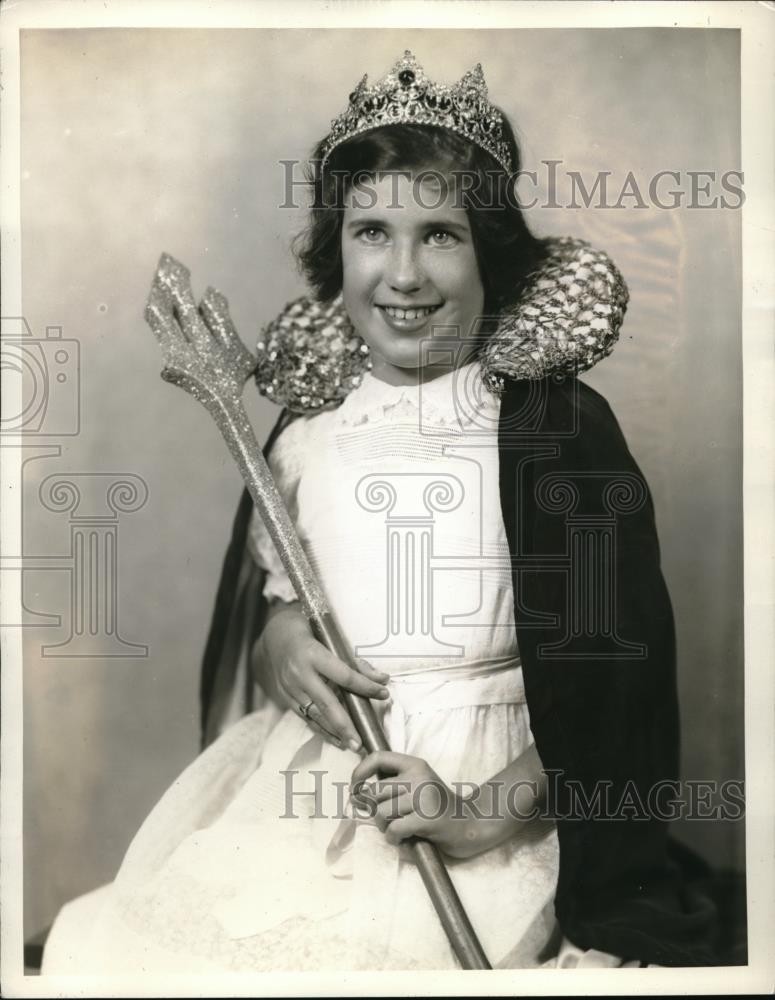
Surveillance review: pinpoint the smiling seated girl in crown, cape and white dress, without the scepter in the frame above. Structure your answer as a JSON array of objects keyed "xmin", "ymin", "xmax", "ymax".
[{"xmin": 44, "ymin": 53, "xmax": 712, "ymax": 972}]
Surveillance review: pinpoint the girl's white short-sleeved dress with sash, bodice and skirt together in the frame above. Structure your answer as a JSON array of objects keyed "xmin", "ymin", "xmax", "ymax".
[{"xmin": 43, "ymin": 362, "xmax": 638, "ymax": 974}]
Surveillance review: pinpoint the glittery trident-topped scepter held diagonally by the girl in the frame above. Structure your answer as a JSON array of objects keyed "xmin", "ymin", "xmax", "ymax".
[{"xmin": 145, "ymin": 254, "xmax": 491, "ymax": 969}]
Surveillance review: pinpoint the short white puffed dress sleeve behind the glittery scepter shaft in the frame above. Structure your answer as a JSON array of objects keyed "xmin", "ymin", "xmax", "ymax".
[{"xmin": 247, "ymin": 418, "xmax": 305, "ymax": 602}]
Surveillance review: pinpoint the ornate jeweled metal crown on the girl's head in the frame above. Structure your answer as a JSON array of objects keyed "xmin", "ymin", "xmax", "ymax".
[{"xmin": 321, "ymin": 49, "xmax": 512, "ymax": 173}]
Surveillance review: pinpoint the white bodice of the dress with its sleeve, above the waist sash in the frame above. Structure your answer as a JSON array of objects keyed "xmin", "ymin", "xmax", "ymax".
[{"xmin": 250, "ymin": 362, "xmax": 517, "ymax": 674}]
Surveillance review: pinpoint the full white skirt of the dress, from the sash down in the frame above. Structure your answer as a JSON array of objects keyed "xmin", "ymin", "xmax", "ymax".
[{"xmin": 42, "ymin": 661, "xmax": 638, "ymax": 975}]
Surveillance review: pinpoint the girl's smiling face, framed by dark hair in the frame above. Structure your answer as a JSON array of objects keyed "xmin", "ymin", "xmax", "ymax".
[{"xmin": 342, "ymin": 174, "xmax": 484, "ymax": 385}]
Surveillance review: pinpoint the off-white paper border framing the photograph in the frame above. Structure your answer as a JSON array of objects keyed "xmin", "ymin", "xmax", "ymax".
[{"xmin": 0, "ymin": 0, "xmax": 775, "ymax": 997}]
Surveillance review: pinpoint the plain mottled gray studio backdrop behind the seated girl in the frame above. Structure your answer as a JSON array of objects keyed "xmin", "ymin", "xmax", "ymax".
[{"xmin": 20, "ymin": 29, "xmax": 744, "ymax": 933}]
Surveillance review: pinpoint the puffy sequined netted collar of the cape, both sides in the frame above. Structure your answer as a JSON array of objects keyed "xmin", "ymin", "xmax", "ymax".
[{"xmin": 256, "ymin": 237, "xmax": 629, "ymax": 413}]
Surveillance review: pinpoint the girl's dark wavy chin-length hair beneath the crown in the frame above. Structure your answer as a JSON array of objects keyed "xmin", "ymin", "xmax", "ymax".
[{"xmin": 294, "ymin": 116, "xmax": 546, "ymax": 316}]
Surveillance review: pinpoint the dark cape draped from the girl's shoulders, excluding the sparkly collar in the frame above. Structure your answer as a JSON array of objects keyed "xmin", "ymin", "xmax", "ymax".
[{"xmin": 201, "ymin": 376, "xmax": 720, "ymax": 966}]
